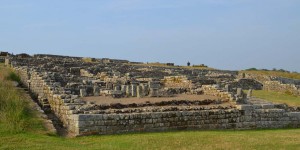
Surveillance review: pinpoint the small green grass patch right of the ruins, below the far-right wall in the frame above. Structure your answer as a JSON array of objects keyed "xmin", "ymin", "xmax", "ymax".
[{"xmin": 253, "ymin": 90, "xmax": 300, "ymax": 106}]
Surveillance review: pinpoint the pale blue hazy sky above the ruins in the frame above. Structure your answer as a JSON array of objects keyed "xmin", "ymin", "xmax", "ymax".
[{"xmin": 0, "ymin": 0, "xmax": 300, "ymax": 72}]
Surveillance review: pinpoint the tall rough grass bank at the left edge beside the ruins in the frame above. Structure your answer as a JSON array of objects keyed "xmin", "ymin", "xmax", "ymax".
[{"xmin": 0, "ymin": 66, "xmax": 33, "ymax": 132}]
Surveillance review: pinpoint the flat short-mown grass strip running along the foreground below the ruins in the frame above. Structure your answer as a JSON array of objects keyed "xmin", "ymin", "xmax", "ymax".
[{"xmin": 0, "ymin": 129, "xmax": 300, "ymax": 150}]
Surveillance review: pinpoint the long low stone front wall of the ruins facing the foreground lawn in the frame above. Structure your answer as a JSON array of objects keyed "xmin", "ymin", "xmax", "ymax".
[{"xmin": 71, "ymin": 105, "xmax": 300, "ymax": 135}]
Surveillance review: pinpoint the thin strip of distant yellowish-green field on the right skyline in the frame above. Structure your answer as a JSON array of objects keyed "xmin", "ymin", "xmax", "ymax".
[{"xmin": 240, "ymin": 70, "xmax": 300, "ymax": 80}]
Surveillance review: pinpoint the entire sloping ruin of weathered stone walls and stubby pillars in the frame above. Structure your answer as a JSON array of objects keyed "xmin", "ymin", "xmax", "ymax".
[{"xmin": 5, "ymin": 54, "xmax": 300, "ymax": 136}]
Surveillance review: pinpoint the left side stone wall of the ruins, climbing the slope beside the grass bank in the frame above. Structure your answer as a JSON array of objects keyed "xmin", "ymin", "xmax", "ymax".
[{"xmin": 14, "ymin": 67, "xmax": 84, "ymax": 134}]
